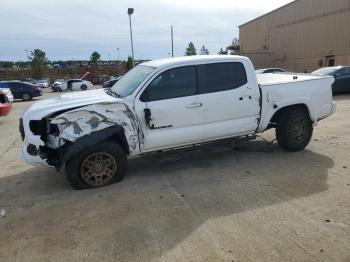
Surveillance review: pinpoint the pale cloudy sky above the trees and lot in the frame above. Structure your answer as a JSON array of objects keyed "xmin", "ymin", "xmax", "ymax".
[{"xmin": 0, "ymin": 0, "xmax": 292, "ymax": 61}]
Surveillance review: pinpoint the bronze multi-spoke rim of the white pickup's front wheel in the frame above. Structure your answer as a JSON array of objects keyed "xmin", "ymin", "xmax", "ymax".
[{"xmin": 80, "ymin": 152, "xmax": 118, "ymax": 186}]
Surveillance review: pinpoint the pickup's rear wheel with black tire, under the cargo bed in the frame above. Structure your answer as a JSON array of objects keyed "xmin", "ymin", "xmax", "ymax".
[{"xmin": 276, "ymin": 108, "xmax": 313, "ymax": 152}]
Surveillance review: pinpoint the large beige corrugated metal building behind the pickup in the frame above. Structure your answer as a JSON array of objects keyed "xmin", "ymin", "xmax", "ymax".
[{"xmin": 239, "ymin": 0, "xmax": 350, "ymax": 72}]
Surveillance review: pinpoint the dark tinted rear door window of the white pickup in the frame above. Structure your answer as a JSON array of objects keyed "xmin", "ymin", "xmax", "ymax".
[{"xmin": 199, "ymin": 62, "xmax": 248, "ymax": 94}]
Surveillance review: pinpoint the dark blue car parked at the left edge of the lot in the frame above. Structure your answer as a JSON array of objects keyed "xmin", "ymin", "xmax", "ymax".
[{"xmin": 0, "ymin": 81, "xmax": 42, "ymax": 101}]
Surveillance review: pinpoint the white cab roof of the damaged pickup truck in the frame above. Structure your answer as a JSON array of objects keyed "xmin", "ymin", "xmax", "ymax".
[{"xmin": 141, "ymin": 55, "xmax": 248, "ymax": 68}]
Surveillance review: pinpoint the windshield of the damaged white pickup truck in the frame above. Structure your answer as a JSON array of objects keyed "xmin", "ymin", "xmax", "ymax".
[{"xmin": 111, "ymin": 65, "xmax": 154, "ymax": 98}]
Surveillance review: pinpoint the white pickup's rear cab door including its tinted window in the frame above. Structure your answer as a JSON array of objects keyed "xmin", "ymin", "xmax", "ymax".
[{"xmin": 198, "ymin": 62, "xmax": 260, "ymax": 140}]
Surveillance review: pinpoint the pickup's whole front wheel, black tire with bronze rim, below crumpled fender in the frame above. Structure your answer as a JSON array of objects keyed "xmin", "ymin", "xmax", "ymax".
[{"xmin": 66, "ymin": 140, "xmax": 127, "ymax": 189}]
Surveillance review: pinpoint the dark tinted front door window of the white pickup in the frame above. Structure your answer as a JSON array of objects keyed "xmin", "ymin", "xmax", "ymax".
[{"xmin": 147, "ymin": 66, "xmax": 197, "ymax": 101}]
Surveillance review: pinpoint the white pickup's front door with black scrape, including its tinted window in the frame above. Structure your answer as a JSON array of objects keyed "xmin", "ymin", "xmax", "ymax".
[{"xmin": 135, "ymin": 66, "xmax": 203, "ymax": 152}]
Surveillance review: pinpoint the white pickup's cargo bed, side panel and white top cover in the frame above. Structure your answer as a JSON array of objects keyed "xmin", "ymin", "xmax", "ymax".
[{"xmin": 257, "ymin": 73, "xmax": 335, "ymax": 132}]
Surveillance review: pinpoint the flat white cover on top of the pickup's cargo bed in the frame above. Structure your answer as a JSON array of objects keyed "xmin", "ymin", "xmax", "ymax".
[{"xmin": 256, "ymin": 73, "xmax": 329, "ymax": 87}]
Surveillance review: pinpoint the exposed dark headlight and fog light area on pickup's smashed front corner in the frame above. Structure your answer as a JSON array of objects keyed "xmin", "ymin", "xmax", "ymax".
[{"xmin": 26, "ymin": 118, "xmax": 61, "ymax": 166}]
